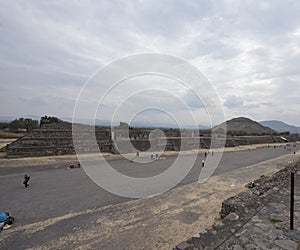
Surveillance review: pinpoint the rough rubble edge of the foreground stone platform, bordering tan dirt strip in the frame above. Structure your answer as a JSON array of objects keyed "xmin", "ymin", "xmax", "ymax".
[{"xmin": 173, "ymin": 159, "xmax": 300, "ymax": 250}]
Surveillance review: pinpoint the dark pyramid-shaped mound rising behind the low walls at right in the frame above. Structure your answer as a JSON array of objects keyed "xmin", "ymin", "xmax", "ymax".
[{"xmin": 213, "ymin": 117, "xmax": 276, "ymax": 135}]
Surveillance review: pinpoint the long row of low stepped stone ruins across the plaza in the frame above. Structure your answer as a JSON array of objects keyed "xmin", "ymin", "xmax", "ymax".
[{"xmin": 1, "ymin": 122, "xmax": 299, "ymax": 157}]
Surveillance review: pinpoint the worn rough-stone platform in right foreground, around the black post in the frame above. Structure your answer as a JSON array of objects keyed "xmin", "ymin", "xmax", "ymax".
[{"xmin": 175, "ymin": 160, "xmax": 300, "ymax": 250}]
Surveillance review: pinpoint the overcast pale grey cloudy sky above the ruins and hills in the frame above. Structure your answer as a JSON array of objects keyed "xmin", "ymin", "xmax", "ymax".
[{"xmin": 0, "ymin": 0, "xmax": 300, "ymax": 126}]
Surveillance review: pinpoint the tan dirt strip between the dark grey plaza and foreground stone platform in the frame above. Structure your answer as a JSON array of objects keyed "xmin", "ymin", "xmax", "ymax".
[{"xmin": 0, "ymin": 152, "xmax": 299, "ymax": 249}]
